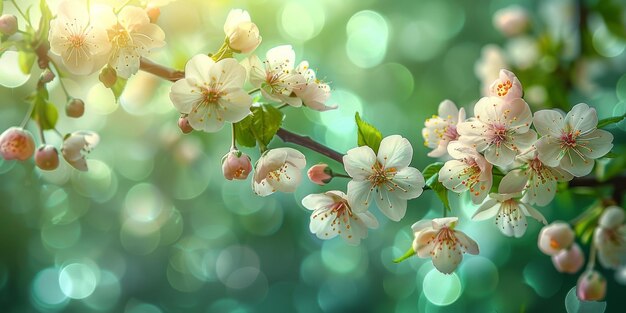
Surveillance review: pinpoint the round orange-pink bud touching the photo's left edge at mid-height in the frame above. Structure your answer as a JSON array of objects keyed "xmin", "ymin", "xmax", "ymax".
[{"xmin": 0, "ymin": 127, "xmax": 35, "ymax": 161}]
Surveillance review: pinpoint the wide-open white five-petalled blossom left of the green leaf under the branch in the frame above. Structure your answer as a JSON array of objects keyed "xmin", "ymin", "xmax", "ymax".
[{"xmin": 170, "ymin": 54, "xmax": 252, "ymax": 132}]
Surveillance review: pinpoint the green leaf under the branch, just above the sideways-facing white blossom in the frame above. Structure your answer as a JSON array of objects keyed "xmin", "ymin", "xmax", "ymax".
[{"xmin": 235, "ymin": 104, "xmax": 283, "ymax": 147}]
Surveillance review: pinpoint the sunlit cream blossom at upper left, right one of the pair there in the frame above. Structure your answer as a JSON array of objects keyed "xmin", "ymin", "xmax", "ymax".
[{"xmin": 108, "ymin": 5, "xmax": 165, "ymax": 78}]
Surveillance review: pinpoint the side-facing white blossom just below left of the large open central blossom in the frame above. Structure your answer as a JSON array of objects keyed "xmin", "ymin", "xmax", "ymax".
[{"xmin": 302, "ymin": 191, "xmax": 378, "ymax": 245}]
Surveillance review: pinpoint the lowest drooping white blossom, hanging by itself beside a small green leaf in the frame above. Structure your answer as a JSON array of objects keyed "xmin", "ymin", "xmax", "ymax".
[{"xmin": 411, "ymin": 217, "xmax": 478, "ymax": 274}]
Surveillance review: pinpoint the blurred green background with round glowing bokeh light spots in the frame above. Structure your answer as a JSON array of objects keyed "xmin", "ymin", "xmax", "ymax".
[{"xmin": 0, "ymin": 0, "xmax": 626, "ymax": 313}]
